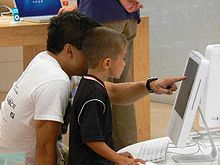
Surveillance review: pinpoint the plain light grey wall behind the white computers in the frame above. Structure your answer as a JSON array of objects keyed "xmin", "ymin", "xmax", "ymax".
[{"xmin": 141, "ymin": 0, "xmax": 220, "ymax": 103}]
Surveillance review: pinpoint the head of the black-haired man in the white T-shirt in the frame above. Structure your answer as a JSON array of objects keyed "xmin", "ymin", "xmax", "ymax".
[{"xmin": 47, "ymin": 12, "xmax": 101, "ymax": 76}]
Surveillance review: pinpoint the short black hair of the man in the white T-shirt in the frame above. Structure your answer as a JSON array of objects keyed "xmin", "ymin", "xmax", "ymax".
[{"xmin": 47, "ymin": 11, "xmax": 101, "ymax": 54}]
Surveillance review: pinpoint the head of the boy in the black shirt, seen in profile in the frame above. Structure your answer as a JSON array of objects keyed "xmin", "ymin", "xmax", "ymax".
[{"xmin": 82, "ymin": 27, "xmax": 128, "ymax": 78}]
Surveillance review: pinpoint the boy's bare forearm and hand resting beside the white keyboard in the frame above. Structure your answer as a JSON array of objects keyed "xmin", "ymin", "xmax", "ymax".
[{"xmin": 86, "ymin": 142, "xmax": 143, "ymax": 165}]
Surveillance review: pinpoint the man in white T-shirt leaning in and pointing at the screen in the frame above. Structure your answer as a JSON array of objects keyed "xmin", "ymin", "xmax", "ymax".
[{"xmin": 0, "ymin": 12, "xmax": 184, "ymax": 165}]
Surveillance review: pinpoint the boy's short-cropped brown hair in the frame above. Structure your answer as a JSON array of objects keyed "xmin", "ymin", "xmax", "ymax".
[{"xmin": 82, "ymin": 27, "xmax": 127, "ymax": 68}]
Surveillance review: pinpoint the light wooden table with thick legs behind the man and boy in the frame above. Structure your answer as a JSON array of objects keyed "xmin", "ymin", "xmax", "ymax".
[{"xmin": 0, "ymin": 17, "xmax": 150, "ymax": 141}]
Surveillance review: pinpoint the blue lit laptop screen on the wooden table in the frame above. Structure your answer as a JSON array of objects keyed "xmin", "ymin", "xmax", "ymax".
[{"xmin": 14, "ymin": 0, "xmax": 62, "ymax": 17}]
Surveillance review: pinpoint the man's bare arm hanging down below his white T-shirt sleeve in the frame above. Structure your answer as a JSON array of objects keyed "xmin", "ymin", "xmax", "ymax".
[{"xmin": 35, "ymin": 120, "xmax": 61, "ymax": 165}]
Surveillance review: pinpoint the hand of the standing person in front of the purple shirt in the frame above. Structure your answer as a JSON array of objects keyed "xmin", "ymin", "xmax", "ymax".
[{"xmin": 119, "ymin": 0, "xmax": 143, "ymax": 13}]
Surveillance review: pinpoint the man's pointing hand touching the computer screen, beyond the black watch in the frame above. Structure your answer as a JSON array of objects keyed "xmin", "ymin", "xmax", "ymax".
[{"xmin": 150, "ymin": 76, "xmax": 186, "ymax": 95}]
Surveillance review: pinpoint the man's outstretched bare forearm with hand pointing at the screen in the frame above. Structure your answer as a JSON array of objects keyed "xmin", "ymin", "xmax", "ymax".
[{"xmin": 105, "ymin": 77, "xmax": 186, "ymax": 105}]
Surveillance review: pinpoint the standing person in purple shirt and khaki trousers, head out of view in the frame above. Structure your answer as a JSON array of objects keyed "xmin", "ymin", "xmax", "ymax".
[{"xmin": 59, "ymin": 0, "xmax": 143, "ymax": 149}]
